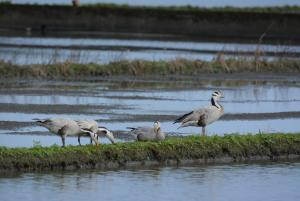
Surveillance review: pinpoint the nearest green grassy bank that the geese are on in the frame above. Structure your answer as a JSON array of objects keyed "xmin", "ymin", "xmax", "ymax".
[{"xmin": 0, "ymin": 133, "xmax": 300, "ymax": 171}]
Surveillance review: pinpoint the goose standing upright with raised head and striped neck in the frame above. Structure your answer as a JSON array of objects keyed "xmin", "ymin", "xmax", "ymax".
[{"xmin": 174, "ymin": 91, "xmax": 224, "ymax": 135}]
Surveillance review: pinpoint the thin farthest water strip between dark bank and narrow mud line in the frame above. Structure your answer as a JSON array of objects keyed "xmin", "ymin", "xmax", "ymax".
[{"xmin": 0, "ymin": 37, "xmax": 300, "ymax": 52}]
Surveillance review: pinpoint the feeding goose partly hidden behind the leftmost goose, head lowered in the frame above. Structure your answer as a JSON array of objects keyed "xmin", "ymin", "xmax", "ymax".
[{"xmin": 76, "ymin": 119, "xmax": 115, "ymax": 144}]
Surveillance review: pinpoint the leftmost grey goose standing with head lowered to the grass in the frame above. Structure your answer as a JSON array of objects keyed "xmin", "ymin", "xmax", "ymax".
[{"xmin": 33, "ymin": 118, "xmax": 98, "ymax": 147}]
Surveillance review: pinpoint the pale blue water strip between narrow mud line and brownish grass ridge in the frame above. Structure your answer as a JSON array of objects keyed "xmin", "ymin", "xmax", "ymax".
[{"xmin": 0, "ymin": 47, "xmax": 216, "ymax": 65}]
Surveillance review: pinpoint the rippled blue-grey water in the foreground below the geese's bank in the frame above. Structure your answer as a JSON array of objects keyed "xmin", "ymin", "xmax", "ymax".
[{"xmin": 0, "ymin": 163, "xmax": 300, "ymax": 201}]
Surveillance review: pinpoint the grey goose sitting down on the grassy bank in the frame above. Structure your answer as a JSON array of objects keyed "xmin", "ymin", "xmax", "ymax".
[{"xmin": 127, "ymin": 121, "xmax": 166, "ymax": 141}]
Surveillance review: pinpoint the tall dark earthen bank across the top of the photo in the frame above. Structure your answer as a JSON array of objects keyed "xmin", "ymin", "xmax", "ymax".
[{"xmin": 0, "ymin": 4, "xmax": 300, "ymax": 42}]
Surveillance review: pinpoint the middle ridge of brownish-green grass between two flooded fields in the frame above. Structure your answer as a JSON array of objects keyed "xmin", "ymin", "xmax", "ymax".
[{"xmin": 0, "ymin": 59, "xmax": 300, "ymax": 79}]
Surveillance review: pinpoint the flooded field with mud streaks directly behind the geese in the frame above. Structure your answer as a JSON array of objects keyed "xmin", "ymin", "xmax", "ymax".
[{"xmin": 0, "ymin": 75, "xmax": 300, "ymax": 147}]
